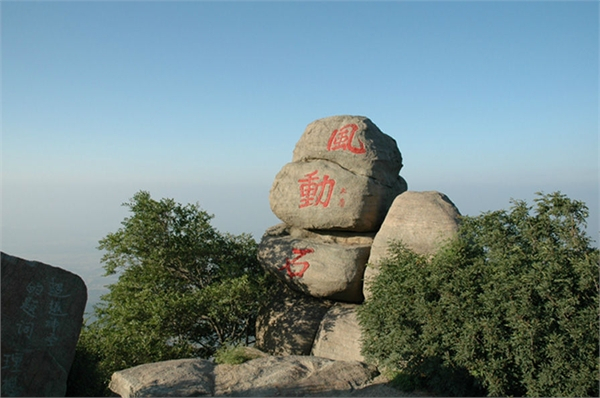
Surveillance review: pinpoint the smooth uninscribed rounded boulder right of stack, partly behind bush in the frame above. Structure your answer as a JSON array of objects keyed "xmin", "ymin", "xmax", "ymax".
[{"xmin": 364, "ymin": 191, "xmax": 460, "ymax": 297}]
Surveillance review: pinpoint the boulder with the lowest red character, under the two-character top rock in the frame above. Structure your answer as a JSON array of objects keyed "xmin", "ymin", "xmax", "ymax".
[{"xmin": 258, "ymin": 224, "xmax": 371, "ymax": 303}]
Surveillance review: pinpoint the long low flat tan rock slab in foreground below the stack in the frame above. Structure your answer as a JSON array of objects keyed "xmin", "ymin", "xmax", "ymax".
[{"xmin": 109, "ymin": 355, "xmax": 377, "ymax": 397}]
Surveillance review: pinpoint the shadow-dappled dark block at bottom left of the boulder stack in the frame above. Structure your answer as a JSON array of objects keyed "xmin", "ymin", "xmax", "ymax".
[{"xmin": 255, "ymin": 286, "xmax": 333, "ymax": 355}]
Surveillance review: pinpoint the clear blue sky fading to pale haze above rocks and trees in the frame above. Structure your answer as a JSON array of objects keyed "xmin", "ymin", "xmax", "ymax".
[{"xmin": 0, "ymin": 0, "xmax": 599, "ymax": 304}]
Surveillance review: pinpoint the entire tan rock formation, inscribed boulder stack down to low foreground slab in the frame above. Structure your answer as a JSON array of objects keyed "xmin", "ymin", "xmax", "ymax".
[{"xmin": 110, "ymin": 116, "xmax": 460, "ymax": 397}]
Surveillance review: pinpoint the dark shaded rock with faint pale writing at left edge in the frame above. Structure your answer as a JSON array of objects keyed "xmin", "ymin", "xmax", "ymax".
[{"xmin": 1, "ymin": 253, "xmax": 87, "ymax": 397}]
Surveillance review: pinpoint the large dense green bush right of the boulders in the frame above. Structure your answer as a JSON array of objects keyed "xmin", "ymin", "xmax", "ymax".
[{"xmin": 359, "ymin": 193, "xmax": 600, "ymax": 396}]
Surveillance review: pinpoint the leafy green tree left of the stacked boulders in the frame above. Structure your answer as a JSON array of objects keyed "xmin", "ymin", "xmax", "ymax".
[{"xmin": 67, "ymin": 191, "xmax": 273, "ymax": 394}]
